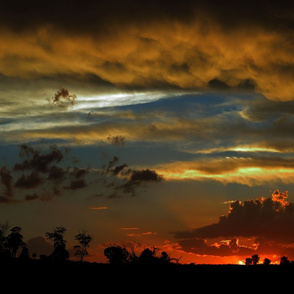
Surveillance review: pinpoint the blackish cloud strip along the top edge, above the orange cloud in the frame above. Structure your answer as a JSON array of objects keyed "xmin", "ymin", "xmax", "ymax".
[{"xmin": 0, "ymin": 0, "xmax": 294, "ymax": 33}]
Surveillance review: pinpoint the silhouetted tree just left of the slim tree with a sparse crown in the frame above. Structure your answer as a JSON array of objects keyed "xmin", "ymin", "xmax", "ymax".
[{"xmin": 46, "ymin": 226, "xmax": 69, "ymax": 261}]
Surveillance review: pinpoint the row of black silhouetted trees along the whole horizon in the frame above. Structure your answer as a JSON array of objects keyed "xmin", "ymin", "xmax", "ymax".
[{"xmin": 0, "ymin": 222, "xmax": 294, "ymax": 266}]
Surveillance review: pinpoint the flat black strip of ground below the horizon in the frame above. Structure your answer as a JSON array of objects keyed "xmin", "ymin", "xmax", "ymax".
[{"xmin": 0, "ymin": 260, "xmax": 294, "ymax": 293}]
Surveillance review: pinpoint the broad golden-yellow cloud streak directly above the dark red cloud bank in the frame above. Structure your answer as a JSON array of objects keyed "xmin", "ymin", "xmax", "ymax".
[{"xmin": 155, "ymin": 157, "xmax": 294, "ymax": 186}]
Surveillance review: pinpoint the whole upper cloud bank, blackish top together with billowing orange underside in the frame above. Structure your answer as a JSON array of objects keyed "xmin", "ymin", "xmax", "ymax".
[{"xmin": 0, "ymin": 0, "xmax": 294, "ymax": 101}]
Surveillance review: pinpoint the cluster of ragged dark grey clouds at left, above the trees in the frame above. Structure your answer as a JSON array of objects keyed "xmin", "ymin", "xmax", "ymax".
[{"xmin": 0, "ymin": 144, "xmax": 163, "ymax": 203}]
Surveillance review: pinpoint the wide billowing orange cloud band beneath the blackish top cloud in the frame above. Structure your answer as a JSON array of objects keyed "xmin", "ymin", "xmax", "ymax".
[{"xmin": 0, "ymin": 3, "xmax": 294, "ymax": 101}]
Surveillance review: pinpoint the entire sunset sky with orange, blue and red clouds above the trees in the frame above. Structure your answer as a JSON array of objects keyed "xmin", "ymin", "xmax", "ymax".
[{"xmin": 0, "ymin": 0, "xmax": 294, "ymax": 264}]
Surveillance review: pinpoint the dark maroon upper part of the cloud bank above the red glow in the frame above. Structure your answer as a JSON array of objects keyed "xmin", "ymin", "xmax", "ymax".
[{"xmin": 174, "ymin": 190, "xmax": 294, "ymax": 244}]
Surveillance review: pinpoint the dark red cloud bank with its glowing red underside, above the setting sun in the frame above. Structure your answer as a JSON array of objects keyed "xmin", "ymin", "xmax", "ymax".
[{"xmin": 173, "ymin": 190, "xmax": 294, "ymax": 256}]
